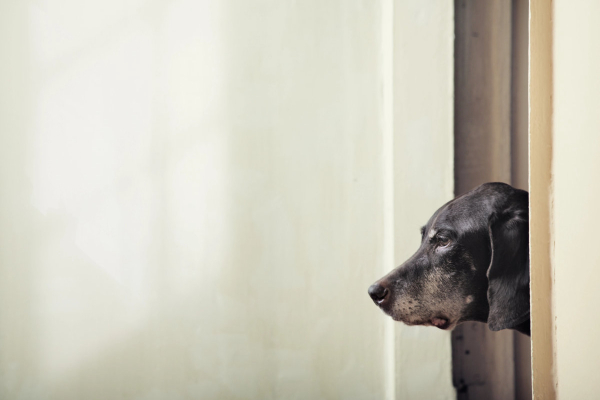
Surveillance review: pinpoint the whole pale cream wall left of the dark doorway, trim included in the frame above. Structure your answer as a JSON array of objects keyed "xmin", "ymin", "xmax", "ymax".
[{"xmin": 0, "ymin": 0, "xmax": 454, "ymax": 400}]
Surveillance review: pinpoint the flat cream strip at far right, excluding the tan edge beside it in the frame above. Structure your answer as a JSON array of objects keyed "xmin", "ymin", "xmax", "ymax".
[{"xmin": 552, "ymin": 0, "xmax": 600, "ymax": 399}]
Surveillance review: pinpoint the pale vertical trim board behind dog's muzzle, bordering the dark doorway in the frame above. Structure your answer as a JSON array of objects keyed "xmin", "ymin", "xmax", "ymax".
[{"xmin": 394, "ymin": 1, "xmax": 456, "ymax": 399}]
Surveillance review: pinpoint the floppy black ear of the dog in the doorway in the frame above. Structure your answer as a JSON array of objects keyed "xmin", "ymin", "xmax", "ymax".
[{"xmin": 487, "ymin": 211, "xmax": 529, "ymax": 331}]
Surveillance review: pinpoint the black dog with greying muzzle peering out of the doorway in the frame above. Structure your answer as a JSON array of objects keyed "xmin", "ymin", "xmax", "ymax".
[{"xmin": 369, "ymin": 183, "xmax": 530, "ymax": 335}]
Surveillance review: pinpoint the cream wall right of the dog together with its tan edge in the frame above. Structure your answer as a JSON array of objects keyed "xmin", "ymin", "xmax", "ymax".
[{"xmin": 531, "ymin": 0, "xmax": 600, "ymax": 399}]
